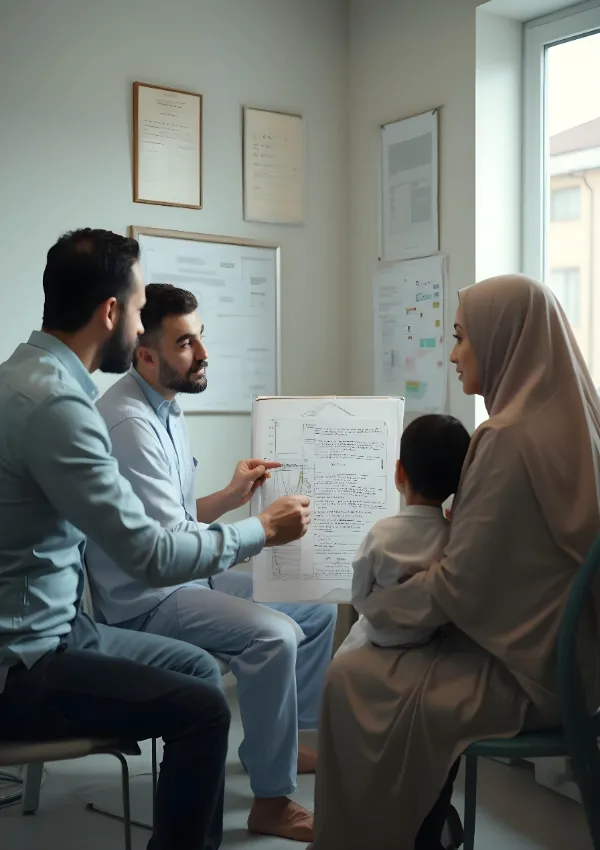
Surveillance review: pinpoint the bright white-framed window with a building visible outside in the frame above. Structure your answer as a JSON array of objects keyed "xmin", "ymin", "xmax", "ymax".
[{"xmin": 523, "ymin": 0, "xmax": 600, "ymax": 385}]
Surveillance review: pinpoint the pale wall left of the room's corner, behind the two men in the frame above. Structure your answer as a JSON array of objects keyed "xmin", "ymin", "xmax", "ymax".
[{"xmin": 0, "ymin": 0, "xmax": 348, "ymax": 516}]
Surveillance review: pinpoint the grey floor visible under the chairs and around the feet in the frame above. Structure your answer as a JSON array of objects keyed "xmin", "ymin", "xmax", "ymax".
[{"xmin": 0, "ymin": 684, "xmax": 592, "ymax": 850}]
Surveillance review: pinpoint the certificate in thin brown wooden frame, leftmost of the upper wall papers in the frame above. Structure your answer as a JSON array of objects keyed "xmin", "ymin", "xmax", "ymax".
[{"xmin": 133, "ymin": 83, "xmax": 202, "ymax": 210}]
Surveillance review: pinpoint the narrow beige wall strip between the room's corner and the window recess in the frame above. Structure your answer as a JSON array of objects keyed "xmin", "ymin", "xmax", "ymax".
[{"xmin": 349, "ymin": 0, "xmax": 477, "ymax": 427}]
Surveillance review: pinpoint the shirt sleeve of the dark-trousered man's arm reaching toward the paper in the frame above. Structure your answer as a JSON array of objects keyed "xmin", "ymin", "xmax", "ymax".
[{"xmin": 27, "ymin": 393, "xmax": 265, "ymax": 587}]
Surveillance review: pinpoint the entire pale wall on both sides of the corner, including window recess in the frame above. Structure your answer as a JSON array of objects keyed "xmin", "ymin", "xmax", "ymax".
[{"xmin": 0, "ymin": 0, "xmax": 536, "ymax": 474}]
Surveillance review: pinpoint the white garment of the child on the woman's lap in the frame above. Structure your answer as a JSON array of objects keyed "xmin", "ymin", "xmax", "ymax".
[{"xmin": 336, "ymin": 505, "xmax": 450, "ymax": 655}]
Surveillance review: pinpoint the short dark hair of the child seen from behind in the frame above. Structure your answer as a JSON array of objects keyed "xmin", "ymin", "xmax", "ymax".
[{"xmin": 400, "ymin": 414, "xmax": 470, "ymax": 502}]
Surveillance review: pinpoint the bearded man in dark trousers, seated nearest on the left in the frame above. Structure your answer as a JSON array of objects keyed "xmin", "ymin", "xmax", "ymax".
[{"xmin": 0, "ymin": 230, "xmax": 310, "ymax": 850}]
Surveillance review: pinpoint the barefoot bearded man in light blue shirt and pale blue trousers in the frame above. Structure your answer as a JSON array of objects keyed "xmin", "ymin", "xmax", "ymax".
[{"xmin": 86, "ymin": 284, "xmax": 336, "ymax": 841}]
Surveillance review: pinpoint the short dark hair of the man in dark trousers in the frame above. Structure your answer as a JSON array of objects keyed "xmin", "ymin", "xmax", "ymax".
[{"xmin": 42, "ymin": 227, "xmax": 140, "ymax": 333}]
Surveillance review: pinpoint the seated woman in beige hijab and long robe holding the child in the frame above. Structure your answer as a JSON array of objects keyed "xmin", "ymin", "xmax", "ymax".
[{"xmin": 313, "ymin": 276, "xmax": 600, "ymax": 850}]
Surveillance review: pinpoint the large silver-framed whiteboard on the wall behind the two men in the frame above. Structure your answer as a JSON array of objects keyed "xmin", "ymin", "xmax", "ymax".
[{"xmin": 131, "ymin": 227, "xmax": 280, "ymax": 413}]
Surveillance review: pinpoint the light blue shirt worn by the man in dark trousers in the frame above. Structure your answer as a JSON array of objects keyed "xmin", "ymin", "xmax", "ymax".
[{"xmin": 0, "ymin": 332, "xmax": 264, "ymax": 672}]
